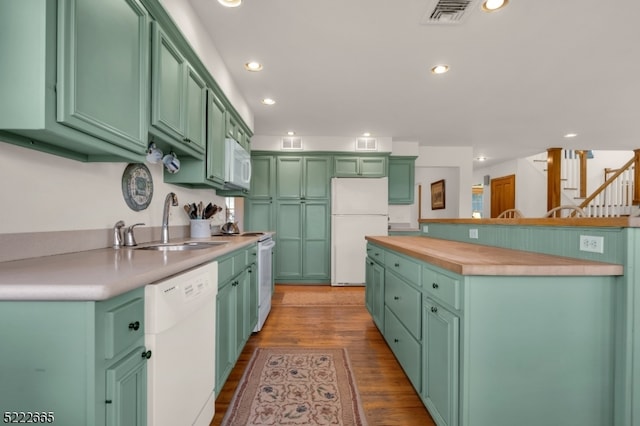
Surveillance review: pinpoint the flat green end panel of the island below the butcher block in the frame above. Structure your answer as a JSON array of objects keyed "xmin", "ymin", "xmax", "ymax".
[{"xmin": 460, "ymin": 276, "xmax": 617, "ymax": 426}]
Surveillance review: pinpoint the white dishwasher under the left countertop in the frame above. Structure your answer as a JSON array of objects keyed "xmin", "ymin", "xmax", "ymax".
[{"xmin": 145, "ymin": 262, "xmax": 218, "ymax": 426}]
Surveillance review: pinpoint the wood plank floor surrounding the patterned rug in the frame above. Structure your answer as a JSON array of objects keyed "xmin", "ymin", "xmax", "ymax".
[{"xmin": 211, "ymin": 285, "xmax": 435, "ymax": 426}]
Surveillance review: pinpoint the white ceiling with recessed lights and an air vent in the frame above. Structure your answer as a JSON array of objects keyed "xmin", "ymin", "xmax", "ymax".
[{"xmin": 189, "ymin": 0, "xmax": 640, "ymax": 165}]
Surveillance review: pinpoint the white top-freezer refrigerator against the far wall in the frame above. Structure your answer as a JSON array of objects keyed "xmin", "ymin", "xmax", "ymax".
[{"xmin": 331, "ymin": 177, "xmax": 389, "ymax": 286}]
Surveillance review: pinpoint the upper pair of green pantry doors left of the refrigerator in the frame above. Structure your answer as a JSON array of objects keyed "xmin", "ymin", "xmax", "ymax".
[{"xmin": 276, "ymin": 156, "xmax": 331, "ymax": 200}]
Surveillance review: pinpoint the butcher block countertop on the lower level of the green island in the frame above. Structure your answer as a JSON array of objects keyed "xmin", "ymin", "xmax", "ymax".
[{"xmin": 366, "ymin": 236, "xmax": 623, "ymax": 276}]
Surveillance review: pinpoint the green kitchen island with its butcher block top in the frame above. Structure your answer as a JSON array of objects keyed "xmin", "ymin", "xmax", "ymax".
[{"xmin": 366, "ymin": 236, "xmax": 623, "ymax": 426}]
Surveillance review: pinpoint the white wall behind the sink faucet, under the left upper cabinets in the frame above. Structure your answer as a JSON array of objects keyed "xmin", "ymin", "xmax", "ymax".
[{"xmin": 0, "ymin": 142, "xmax": 229, "ymax": 234}]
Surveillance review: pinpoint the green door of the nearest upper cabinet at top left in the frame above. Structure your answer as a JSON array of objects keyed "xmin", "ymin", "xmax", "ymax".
[{"xmin": 57, "ymin": 0, "xmax": 149, "ymax": 155}]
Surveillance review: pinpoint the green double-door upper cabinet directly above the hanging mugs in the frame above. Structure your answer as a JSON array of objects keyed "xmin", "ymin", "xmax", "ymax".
[{"xmin": 150, "ymin": 22, "xmax": 206, "ymax": 158}]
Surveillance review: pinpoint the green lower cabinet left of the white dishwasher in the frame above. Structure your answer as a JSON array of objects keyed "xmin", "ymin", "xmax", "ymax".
[{"xmin": 0, "ymin": 289, "xmax": 147, "ymax": 426}]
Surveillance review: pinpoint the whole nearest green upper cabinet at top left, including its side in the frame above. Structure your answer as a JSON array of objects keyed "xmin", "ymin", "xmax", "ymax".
[{"xmin": 0, "ymin": 0, "xmax": 150, "ymax": 161}]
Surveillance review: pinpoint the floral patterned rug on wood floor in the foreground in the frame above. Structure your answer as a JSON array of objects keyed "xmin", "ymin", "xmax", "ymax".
[{"xmin": 222, "ymin": 348, "xmax": 367, "ymax": 426}]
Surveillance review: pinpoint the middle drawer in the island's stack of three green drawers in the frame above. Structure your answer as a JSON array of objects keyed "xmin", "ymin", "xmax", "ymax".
[{"xmin": 384, "ymin": 271, "xmax": 422, "ymax": 339}]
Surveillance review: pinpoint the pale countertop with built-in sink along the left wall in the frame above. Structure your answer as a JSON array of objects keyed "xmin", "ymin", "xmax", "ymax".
[{"xmin": 0, "ymin": 236, "xmax": 258, "ymax": 300}]
